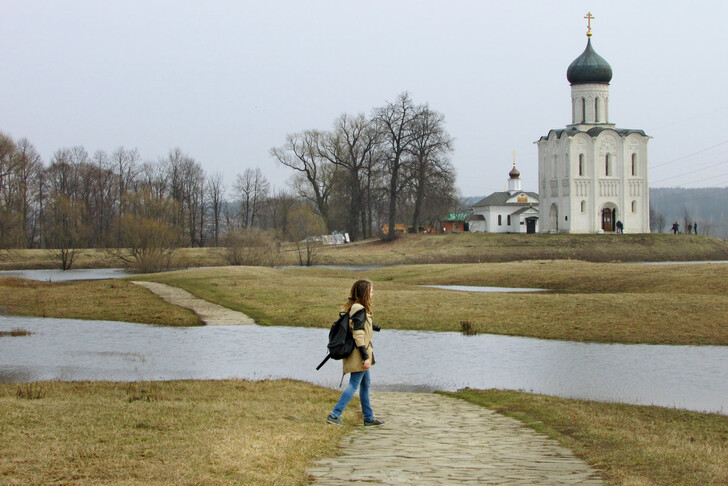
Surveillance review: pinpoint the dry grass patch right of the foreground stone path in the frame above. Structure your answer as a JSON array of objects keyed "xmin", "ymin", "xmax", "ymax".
[{"xmin": 448, "ymin": 390, "xmax": 728, "ymax": 485}]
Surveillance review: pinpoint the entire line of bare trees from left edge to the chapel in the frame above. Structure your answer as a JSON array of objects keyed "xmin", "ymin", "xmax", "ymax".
[{"xmin": 0, "ymin": 93, "xmax": 456, "ymax": 254}]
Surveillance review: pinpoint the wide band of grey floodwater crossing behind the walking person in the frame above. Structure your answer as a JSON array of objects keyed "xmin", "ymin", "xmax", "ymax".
[{"xmin": 0, "ymin": 316, "xmax": 728, "ymax": 414}]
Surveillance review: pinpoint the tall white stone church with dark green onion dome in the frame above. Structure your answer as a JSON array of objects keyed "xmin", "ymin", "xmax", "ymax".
[{"xmin": 535, "ymin": 13, "xmax": 650, "ymax": 233}]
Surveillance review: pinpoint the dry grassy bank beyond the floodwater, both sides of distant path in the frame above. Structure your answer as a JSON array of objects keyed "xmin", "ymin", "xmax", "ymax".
[{"xmin": 0, "ymin": 261, "xmax": 728, "ymax": 345}]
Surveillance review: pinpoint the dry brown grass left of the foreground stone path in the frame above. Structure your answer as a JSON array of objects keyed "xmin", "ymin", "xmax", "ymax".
[{"xmin": 0, "ymin": 380, "xmax": 353, "ymax": 485}]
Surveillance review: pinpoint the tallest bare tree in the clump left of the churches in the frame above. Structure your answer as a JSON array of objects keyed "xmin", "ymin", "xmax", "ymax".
[{"xmin": 372, "ymin": 92, "xmax": 422, "ymax": 241}]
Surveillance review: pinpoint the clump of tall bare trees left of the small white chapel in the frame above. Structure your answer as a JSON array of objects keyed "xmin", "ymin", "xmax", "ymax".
[{"xmin": 271, "ymin": 93, "xmax": 457, "ymax": 240}]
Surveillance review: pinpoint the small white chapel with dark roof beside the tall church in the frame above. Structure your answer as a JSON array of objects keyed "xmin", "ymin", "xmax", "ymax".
[{"xmin": 467, "ymin": 162, "xmax": 538, "ymax": 233}]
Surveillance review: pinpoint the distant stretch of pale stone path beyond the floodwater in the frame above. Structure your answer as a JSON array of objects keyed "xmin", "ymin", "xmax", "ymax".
[{"xmin": 132, "ymin": 281, "xmax": 255, "ymax": 326}]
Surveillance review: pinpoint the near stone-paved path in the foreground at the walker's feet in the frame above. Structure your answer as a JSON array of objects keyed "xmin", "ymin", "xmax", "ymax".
[{"xmin": 308, "ymin": 392, "xmax": 603, "ymax": 485}]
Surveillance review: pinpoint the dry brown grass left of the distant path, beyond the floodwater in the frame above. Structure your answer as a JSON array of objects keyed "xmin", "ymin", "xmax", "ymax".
[{"xmin": 0, "ymin": 277, "xmax": 202, "ymax": 326}]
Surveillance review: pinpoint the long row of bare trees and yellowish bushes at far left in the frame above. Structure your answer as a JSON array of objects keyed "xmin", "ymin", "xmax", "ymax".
[{"xmin": 0, "ymin": 133, "xmax": 305, "ymax": 254}]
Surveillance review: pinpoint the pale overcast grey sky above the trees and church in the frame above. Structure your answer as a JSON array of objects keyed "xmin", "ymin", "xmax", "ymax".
[{"xmin": 0, "ymin": 0, "xmax": 728, "ymax": 196}]
